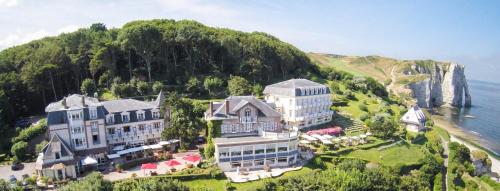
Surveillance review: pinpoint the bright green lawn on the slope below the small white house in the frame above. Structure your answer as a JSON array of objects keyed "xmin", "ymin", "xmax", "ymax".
[{"xmin": 347, "ymin": 143, "xmax": 423, "ymax": 166}]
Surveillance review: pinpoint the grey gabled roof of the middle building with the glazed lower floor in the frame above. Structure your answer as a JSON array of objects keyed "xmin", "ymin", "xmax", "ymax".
[{"xmin": 207, "ymin": 96, "xmax": 281, "ymax": 117}]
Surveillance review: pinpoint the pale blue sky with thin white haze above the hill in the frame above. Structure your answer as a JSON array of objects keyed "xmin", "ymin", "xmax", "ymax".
[{"xmin": 0, "ymin": 0, "xmax": 500, "ymax": 82}]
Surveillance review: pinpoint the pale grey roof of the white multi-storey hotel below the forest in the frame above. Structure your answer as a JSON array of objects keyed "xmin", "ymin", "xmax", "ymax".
[{"xmin": 264, "ymin": 79, "xmax": 330, "ymax": 96}]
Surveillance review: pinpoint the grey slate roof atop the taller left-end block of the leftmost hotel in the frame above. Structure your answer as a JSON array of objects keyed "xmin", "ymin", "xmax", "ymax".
[{"xmin": 45, "ymin": 94, "xmax": 101, "ymax": 112}]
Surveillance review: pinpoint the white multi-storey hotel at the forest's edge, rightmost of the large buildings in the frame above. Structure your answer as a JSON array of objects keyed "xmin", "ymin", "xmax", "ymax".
[{"xmin": 264, "ymin": 79, "xmax": 333, "ymax": 129}]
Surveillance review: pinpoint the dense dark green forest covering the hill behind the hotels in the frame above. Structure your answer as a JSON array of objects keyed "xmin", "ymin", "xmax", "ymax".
[{"xmin": 0, "ymin": 19, "xmax": 320, "ymax": 153}]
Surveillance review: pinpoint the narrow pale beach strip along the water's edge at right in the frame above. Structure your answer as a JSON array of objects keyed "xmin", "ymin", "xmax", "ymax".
[{"xmin": 432, "ymin": 115, "xmax": 500, "ymax": 174}]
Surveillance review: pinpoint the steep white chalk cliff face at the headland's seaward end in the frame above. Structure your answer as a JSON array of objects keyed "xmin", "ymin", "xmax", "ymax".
[{"xmin": 403, "ymin": 62, "xmax": 472, "ymax": 107}]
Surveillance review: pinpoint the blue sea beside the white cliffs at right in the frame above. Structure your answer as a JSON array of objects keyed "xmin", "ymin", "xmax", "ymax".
[{"xmin": 438, "ymin": 80, "xmax": 500, "ymax": 155}]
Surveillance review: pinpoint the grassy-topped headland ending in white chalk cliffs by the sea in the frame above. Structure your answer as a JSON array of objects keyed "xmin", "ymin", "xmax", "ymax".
[{"xmin": 308, "ymin": 53, "xmax": 472, "ymax": 108}]
